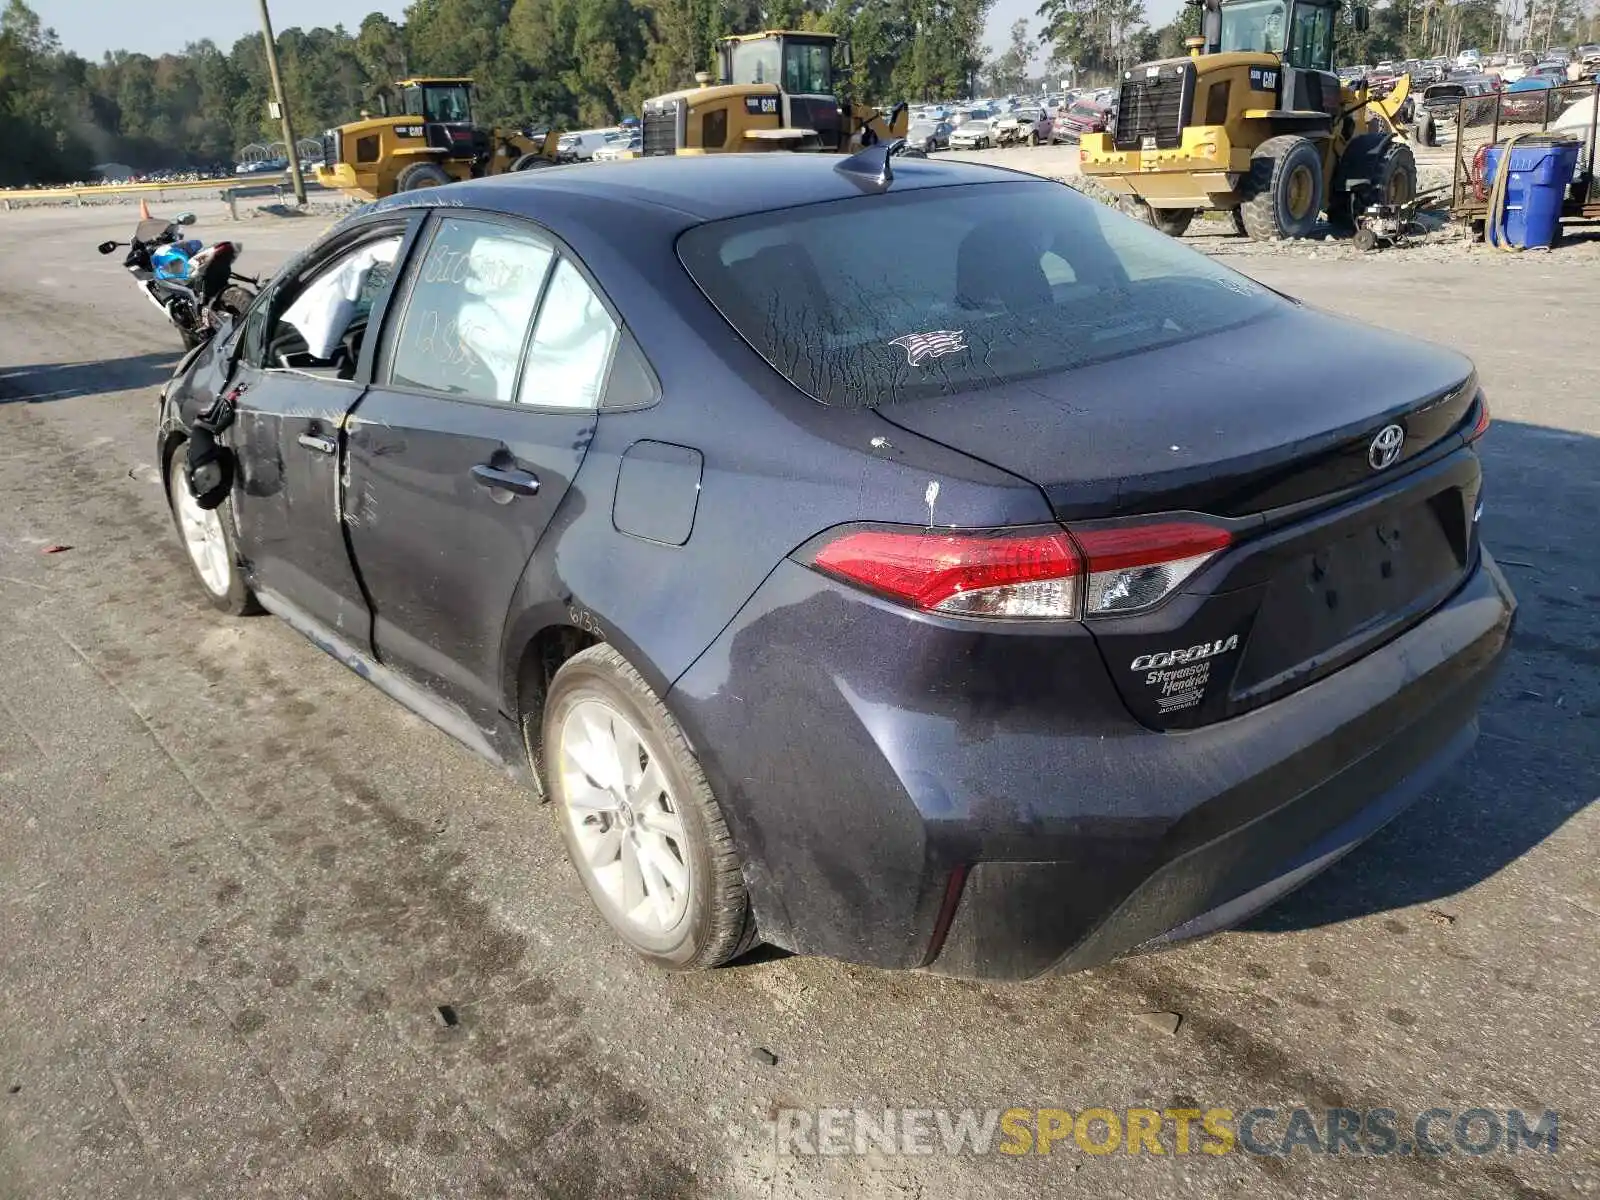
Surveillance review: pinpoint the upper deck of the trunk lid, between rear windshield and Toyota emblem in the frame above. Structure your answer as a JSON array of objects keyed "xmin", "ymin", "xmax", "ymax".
[{"xmin": 878, "ymin": 307, "xmax": 1472, "ymax": 520}]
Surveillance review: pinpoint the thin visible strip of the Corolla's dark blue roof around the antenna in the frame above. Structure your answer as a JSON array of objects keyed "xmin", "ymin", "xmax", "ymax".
[{"xmin": 451, "ymin": 154, "xmax": 1037, "ymax": 221}]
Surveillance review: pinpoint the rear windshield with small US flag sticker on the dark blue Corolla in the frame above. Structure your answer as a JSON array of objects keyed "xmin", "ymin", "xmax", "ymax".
[{"xmin": 678, "ymin": 182, "xmax": 1283, "ymax": 406}]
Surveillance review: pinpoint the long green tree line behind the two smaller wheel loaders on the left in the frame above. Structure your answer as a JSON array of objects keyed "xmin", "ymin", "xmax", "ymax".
[{"xmin": 0, "ymin": 0, "xmax": 994, "ymax": 186}]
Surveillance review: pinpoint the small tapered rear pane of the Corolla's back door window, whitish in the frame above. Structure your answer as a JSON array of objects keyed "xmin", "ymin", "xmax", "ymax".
[{"xmin": 517, "ymin": 258, "xmax": 618, "ymax": 408}]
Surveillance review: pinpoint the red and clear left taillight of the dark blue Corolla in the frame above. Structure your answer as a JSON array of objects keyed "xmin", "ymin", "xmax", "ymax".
[{"xmin": 810, "ymin": 520, "xmax": 1232, "ymax": 621}]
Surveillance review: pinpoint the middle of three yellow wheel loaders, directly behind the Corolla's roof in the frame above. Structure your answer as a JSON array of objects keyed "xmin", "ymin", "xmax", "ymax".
[{"xmin": 640, "ymin": 29, "xmax": 909, "ymax": 158}]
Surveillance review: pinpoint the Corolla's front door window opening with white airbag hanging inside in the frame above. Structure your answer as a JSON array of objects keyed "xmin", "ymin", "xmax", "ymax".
[{"xmin": 264, "ymin": 234, "xmax": 402, "ymax": 379}]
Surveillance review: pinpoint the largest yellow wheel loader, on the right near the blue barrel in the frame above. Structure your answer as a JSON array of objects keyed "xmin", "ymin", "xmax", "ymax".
[{"xmin": 1080, "ymin": 0, "xmax": 1416, "ymax": 242}]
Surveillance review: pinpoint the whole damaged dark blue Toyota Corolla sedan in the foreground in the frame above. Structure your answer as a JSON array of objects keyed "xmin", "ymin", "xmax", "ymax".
[{"xmin": 158, "ymin": 147, "xmax": 1515, "ymax": 978}]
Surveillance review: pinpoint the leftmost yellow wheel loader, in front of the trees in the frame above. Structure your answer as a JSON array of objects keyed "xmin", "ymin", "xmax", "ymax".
[{"xmin": 317, "ymin": 78, "xmax": 560, "ymax": 200}]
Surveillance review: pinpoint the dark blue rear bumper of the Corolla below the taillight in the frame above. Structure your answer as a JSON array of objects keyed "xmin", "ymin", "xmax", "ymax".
[{"xmin": 669, "ymin": 554, "xmax": 1515, "ymax": 979}]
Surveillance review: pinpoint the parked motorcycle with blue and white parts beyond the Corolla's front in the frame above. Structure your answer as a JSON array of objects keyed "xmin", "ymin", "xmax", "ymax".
[{"xmin": 99, "ymin": 210, "xmax": 261, "ymax": 350}]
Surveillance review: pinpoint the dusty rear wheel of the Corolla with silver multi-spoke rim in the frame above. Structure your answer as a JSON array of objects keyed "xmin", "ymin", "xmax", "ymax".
[{"xmin": 542, "ymin": 645, "xmax": 755, "ymax": 971}]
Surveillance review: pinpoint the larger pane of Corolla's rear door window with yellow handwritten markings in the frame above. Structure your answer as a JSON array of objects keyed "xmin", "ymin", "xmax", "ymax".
[{"xmin": 389, "ymin": 216, "xmax": 555, "ymax": 402}]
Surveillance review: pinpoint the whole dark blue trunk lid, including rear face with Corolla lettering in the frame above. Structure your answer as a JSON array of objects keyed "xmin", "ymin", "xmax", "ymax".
[{"xmin": 880, "ymin": 309, "xmax": 1480, "ymax": 730}]
